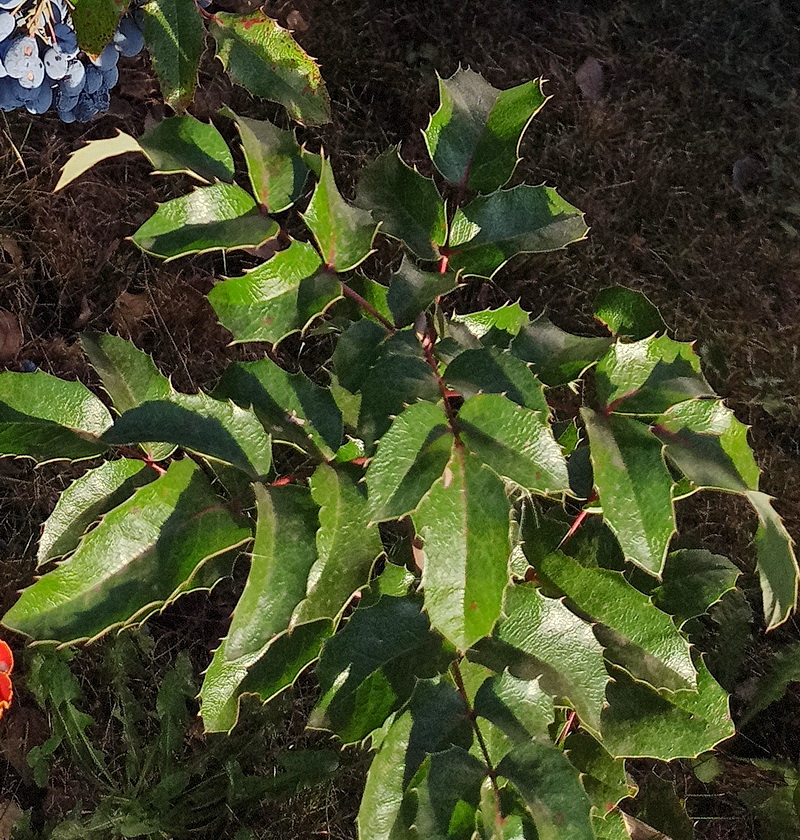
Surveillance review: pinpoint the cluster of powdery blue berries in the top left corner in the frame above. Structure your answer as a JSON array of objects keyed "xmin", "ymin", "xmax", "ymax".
[{"xmin": 0, "ymin": 0, "xmax": 144, "ymax": 123}]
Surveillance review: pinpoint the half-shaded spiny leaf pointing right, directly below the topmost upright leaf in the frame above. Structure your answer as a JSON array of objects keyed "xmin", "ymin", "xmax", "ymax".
[{"xmin": 448, "ymin": 184, "xmax": 588, "ymax": 278}]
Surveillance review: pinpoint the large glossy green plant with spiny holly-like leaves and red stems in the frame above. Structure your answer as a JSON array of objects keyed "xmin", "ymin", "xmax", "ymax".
[{"xmin": 0, "ymin": 70, "xmax": 798, "ymax": 840}]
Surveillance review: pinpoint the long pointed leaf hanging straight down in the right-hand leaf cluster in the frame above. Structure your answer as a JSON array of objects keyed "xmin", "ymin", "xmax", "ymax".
[{"xmin": 581, "ymin": 408, "xmax": 676, "ymax": 575}]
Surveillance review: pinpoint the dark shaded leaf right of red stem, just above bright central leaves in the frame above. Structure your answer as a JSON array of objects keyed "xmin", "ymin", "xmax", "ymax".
[{"xmin": 444, "ymin": 347, "xmax": 550, "ymax": 419}]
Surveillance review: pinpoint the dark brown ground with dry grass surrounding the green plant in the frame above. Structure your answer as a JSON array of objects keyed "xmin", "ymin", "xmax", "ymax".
[{"xmin": 0, "ymin": 0, "xmax": 800, "ymax": 840}]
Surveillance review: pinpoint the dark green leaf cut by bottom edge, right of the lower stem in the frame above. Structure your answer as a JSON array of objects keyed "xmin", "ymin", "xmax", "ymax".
[{"xmin": 497, "ymin": 741, "xmax": 595, "ymax": 840}]
